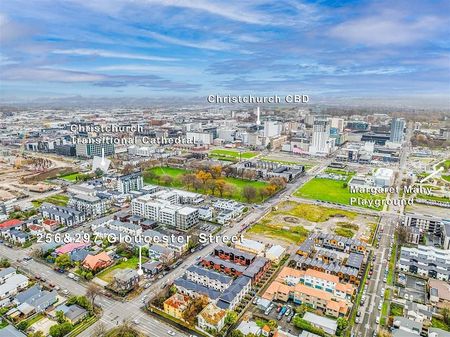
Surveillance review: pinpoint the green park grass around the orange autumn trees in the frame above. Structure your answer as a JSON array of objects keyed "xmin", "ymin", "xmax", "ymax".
[{"xmin": 144, "ymin": 167, "xmax": 269, "ymax": 203}]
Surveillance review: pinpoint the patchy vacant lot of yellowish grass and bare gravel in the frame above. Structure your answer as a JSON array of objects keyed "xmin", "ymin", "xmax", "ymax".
[{"xmin": 246, "ymin": 201, "xmax": 377, "ymax": 245}]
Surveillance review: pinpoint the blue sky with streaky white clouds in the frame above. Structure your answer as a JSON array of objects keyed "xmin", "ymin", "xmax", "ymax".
[{"xmin": 0, "ymin": 0, "xmax": 450, "ymax": 102}]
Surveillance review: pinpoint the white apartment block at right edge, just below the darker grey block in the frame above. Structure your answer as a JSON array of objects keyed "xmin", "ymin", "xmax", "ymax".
[{"xmin": 397, "ymin": 245, "xmax": 450, "ymax": 281}]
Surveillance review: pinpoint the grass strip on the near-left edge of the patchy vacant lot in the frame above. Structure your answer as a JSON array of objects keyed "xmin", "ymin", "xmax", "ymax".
[{"xmin": 247, "ymin": 223, "xmax": 308, "ymax": 244}]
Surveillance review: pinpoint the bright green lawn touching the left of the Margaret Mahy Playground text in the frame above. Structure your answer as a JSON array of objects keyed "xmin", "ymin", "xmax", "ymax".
[{"xmin": 294, "ymin": 178, "xmax": 386, "ymax": 210}]
